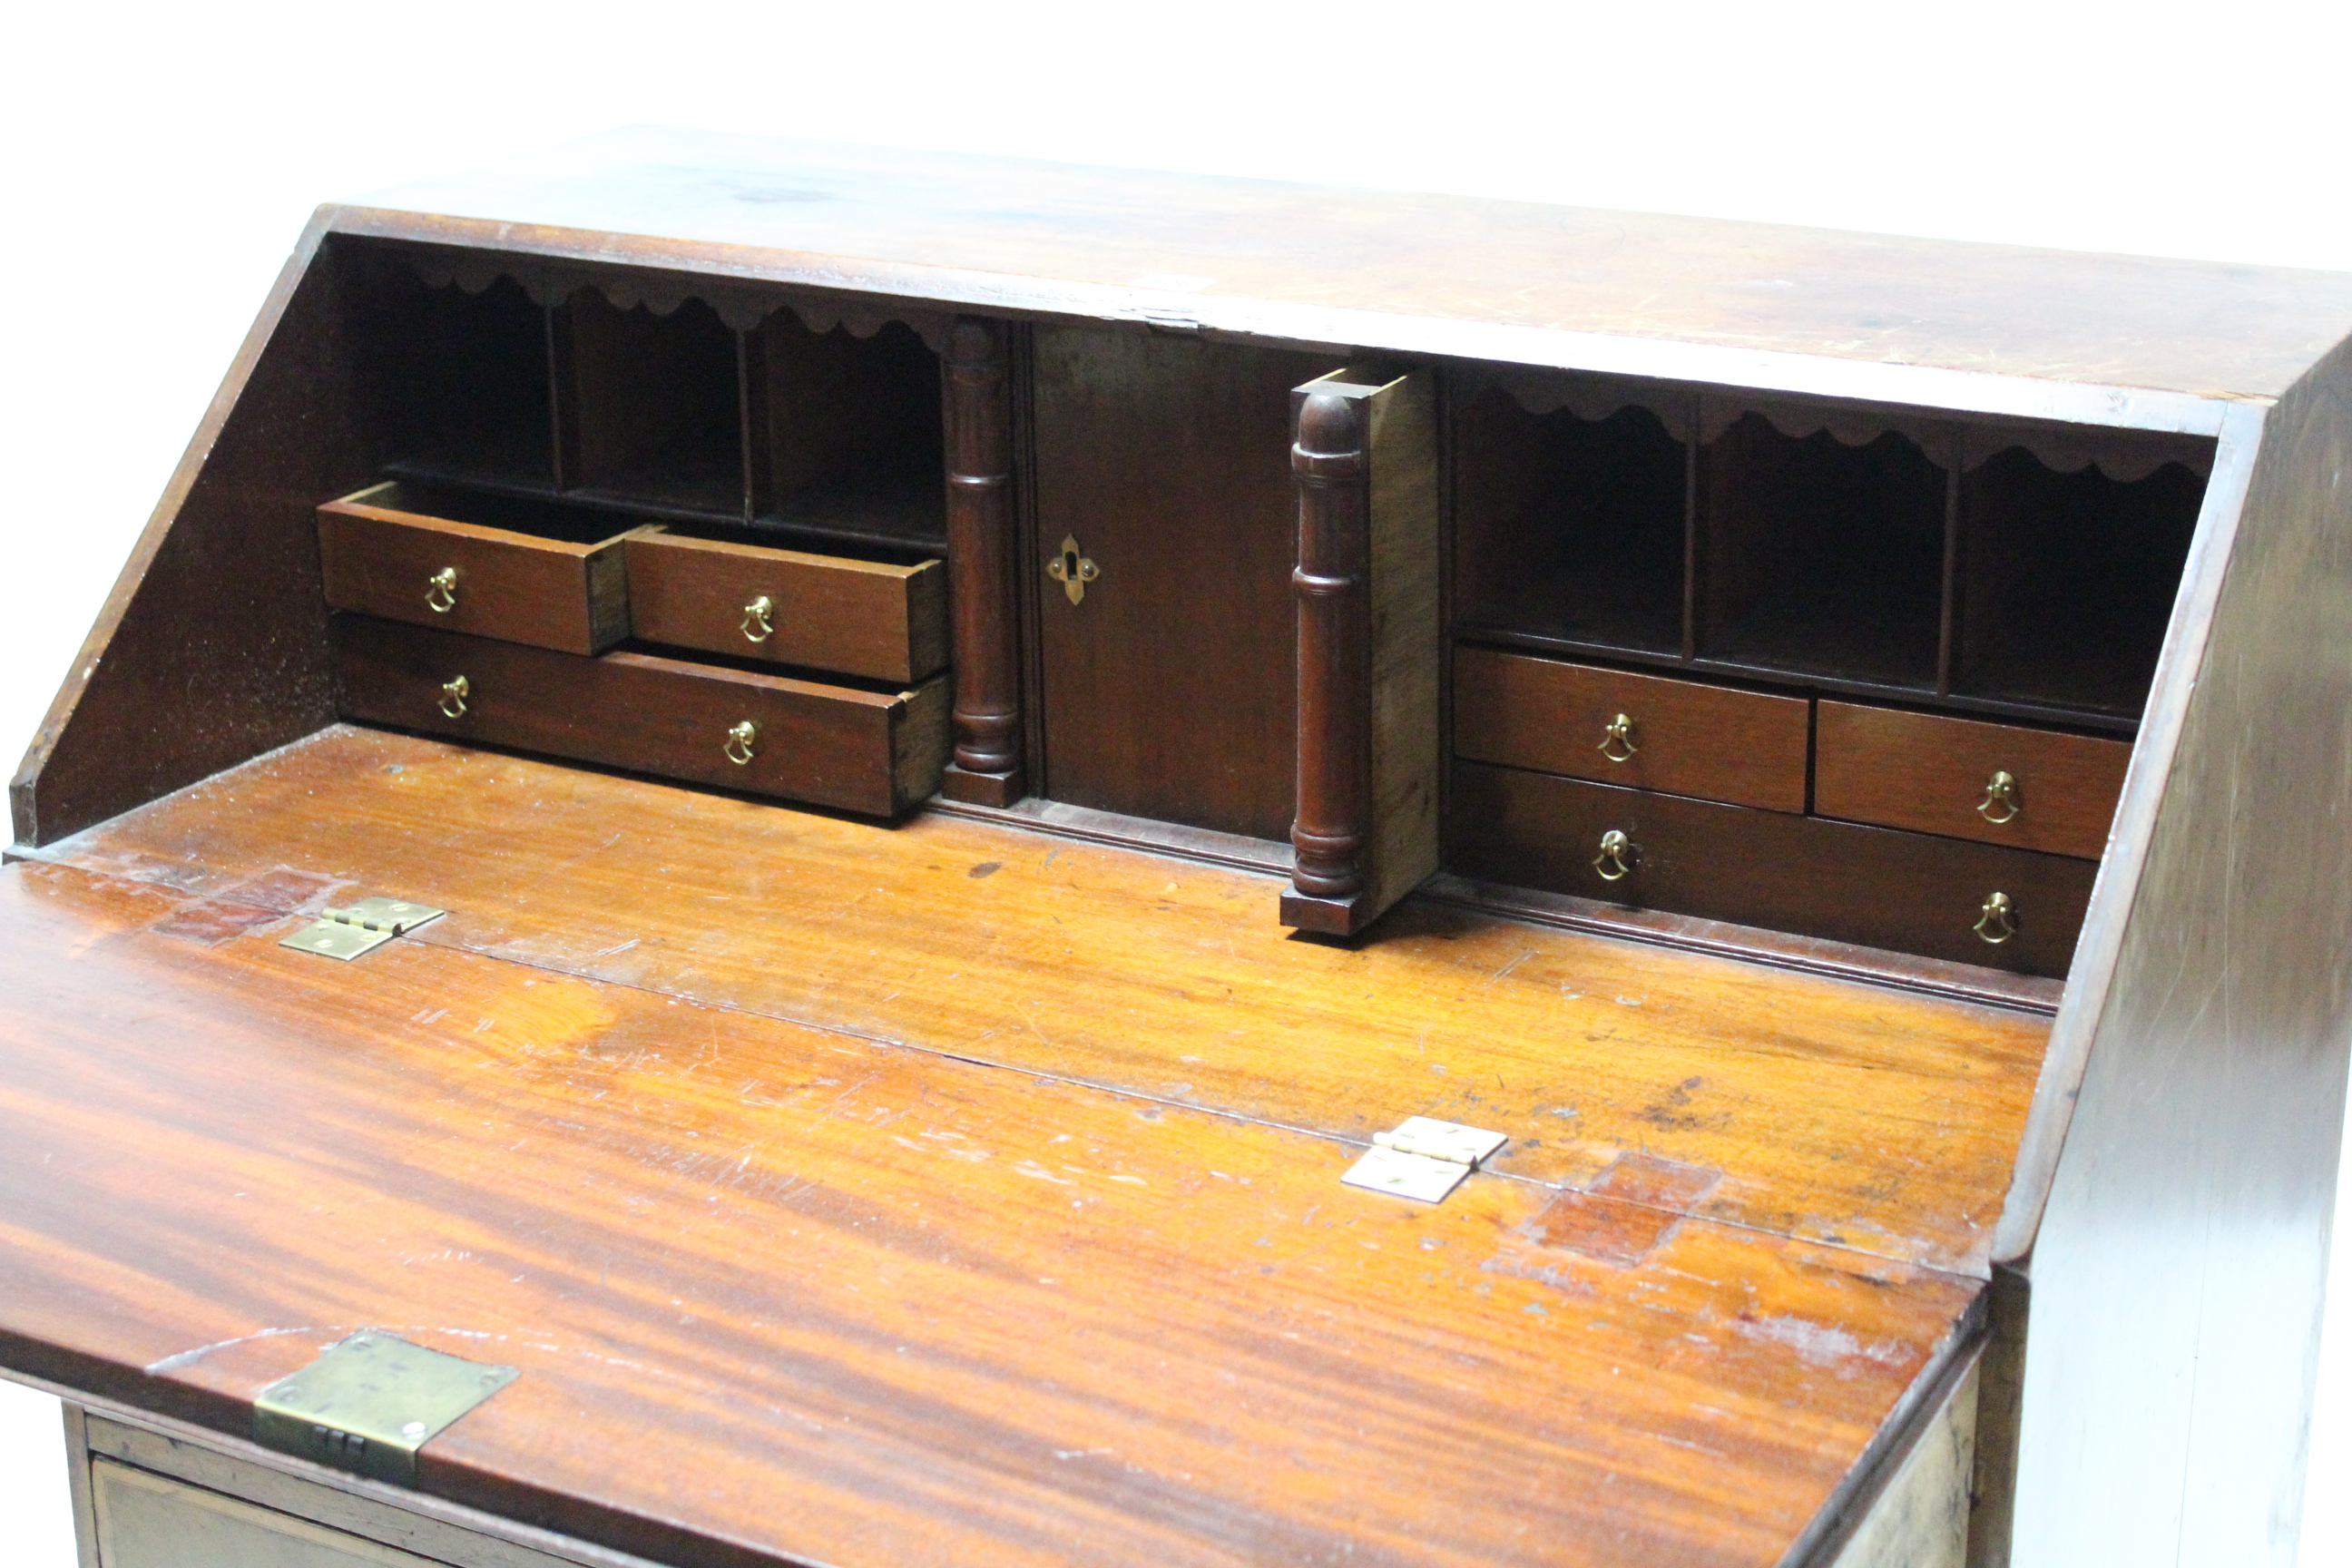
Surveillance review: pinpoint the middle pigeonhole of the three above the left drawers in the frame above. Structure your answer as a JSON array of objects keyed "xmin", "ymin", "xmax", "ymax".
[{"xmin": 557, "ymin": 289, "xmax": 743, "ymax": 520}]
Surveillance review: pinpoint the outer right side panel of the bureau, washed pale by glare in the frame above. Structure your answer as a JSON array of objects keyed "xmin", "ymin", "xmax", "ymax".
[{"xmin": 2004, "ymin": 348, "xmax": 2352, "ymax": 1568}]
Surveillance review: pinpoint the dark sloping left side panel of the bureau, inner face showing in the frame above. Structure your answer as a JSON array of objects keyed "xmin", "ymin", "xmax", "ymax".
[{"xmin": 9, "ymin": 221, "xmax": 365, "ymax": 844}]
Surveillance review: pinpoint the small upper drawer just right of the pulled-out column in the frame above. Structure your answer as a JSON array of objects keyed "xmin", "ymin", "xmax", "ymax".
[{"xmin": 1454, "ymin": 649, "xmax": 1811, "ymax": 811}]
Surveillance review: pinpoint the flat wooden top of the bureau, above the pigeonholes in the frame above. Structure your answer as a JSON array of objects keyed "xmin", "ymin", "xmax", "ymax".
[{"xmin": 320, "ymin": 127, "xmax": 2352, "ymax": 423}]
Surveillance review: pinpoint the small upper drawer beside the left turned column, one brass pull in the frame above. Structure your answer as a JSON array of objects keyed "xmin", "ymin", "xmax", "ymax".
[{"xmin": 628, "ymin": 531, "xmax": 948, "ymax": 681}]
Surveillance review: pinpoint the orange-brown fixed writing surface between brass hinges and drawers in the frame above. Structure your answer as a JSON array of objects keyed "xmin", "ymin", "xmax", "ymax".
[{"xmin": 27, "ymin": 727, "xmax": 2049, "ymax": 1272}]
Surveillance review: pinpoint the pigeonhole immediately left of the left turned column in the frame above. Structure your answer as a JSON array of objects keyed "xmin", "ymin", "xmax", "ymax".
[{"xmin": 746, "ymin": 310, "xmax": 948, "ymax": 550}]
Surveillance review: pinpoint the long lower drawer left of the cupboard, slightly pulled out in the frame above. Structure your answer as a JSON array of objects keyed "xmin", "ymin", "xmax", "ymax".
[{"xmin": 337, "ymin": 616, "xmax": 948, "ymax": 816}]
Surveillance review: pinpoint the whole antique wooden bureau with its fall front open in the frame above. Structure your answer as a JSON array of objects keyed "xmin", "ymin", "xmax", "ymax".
[{"xmin": 0, "ymin": 129, "xmax": 2352, "ymax": 1568}]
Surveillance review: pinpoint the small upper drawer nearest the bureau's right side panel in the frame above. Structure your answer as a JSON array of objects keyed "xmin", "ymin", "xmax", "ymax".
[{"xmin": 1813, "ymin": 701, "xmax": 2131, "ymax": 860}]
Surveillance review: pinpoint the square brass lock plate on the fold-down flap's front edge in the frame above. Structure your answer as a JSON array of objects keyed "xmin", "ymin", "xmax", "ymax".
[{"xmin": 254, "ymin": 1328, "xmax": 522, "ymax": 1485}]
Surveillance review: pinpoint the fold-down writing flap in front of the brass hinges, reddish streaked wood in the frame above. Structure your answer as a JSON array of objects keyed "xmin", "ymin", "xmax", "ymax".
[{"xmin": 0, "ymin": 860, "xmax": 1978, "ymax": 1565}]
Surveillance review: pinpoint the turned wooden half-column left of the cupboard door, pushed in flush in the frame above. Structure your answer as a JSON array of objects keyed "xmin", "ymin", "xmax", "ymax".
[{"xmin": 941, "ymin": 315, "xmax": 1025, "ymax": 807}]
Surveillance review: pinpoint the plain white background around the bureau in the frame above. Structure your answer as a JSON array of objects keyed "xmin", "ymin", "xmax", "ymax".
[{"xmin": 0, "ymin": 0, "xmax": 2352, "ymax": 1568}]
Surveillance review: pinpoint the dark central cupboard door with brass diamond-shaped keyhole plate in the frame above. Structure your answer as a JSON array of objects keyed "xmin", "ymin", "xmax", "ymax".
[{"xmin": 1030, "ymin": 327, "xmax": 1336, "ymax": 839}]
